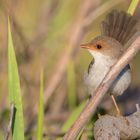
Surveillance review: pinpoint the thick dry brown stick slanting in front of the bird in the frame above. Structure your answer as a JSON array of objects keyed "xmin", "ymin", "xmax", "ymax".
[{"xmin": 64, "ymin": 33, "xmax": 140, "ymax": 140}]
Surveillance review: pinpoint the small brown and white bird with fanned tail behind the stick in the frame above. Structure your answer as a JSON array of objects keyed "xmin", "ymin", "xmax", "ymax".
[{"xmin": 81, "ymin": 10, "xmax": 137, "ymax": 114}]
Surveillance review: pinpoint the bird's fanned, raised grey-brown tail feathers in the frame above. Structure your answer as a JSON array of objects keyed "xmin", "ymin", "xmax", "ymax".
[{"xmin": 101, "ymin": 10, "xmax": 137, "ymax": 45}]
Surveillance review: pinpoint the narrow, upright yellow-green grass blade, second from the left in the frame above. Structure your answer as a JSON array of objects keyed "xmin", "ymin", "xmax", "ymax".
[{"xmin": 37, "ymin": 72, "xmax": 44, "ymax": 140}]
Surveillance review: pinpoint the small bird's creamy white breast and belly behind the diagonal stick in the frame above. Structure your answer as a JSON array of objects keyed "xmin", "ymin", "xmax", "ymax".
[{"xmin": 84, "ymin": 55, "xmax": 131, "ymax": 95}]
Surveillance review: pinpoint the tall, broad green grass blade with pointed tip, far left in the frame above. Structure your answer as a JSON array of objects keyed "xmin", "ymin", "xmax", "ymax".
[{"xmin": 8, "ymin": 20, "xmax": 24, "ymax": 140}]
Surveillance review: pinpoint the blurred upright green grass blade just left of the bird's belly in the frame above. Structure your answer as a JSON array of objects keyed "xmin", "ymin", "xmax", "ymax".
[{"xmin": 67, "ymin": 60, "xmax": 76, "ymax": 109}]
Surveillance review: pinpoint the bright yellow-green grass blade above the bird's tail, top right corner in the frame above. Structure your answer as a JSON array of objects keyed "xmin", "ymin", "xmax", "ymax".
[{"xmin": 127, "ymin": 0, "xmax": 139, "ymax": 15}]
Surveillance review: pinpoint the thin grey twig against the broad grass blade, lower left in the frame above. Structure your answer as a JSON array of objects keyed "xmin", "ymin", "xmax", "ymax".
[{"xmin": 5, "ymin": 104, "xmax": 15, "ymax": 140}]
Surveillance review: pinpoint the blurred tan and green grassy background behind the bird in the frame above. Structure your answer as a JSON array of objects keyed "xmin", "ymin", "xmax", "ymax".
[{"xmin": 0, "ymin": 0, "xmax": 140, "ymax": 139}]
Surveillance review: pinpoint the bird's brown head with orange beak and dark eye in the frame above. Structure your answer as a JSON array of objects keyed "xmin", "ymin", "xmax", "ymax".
[{"xmin": 81, "ymin": 36, "xmax": 123, "ymax": 60}]
